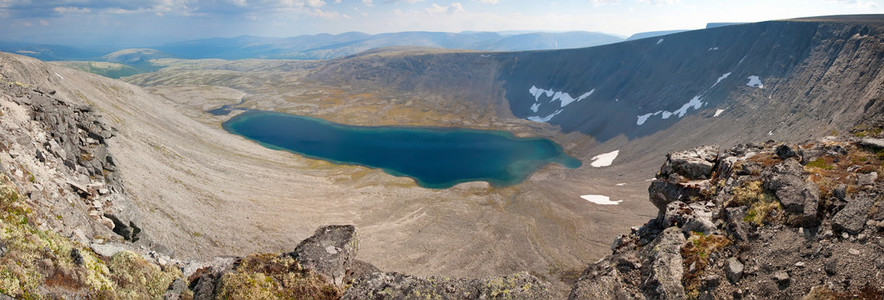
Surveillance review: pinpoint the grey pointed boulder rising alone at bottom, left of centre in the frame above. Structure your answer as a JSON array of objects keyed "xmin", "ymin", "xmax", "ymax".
[{"xmin": 289, "ymin": 225, "xmax": 356, "ymax": 286}]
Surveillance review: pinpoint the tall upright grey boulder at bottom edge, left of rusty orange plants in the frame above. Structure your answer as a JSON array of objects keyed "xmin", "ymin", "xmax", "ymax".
[{"xmin": 641, "ymin": 227, "xmax": 686, "ymax": 299}]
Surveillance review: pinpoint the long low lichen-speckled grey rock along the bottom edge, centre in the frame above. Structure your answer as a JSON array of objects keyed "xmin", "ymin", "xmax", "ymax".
[{"xmin": 341, "ymin": 272, "xmax": 551, "ymax": 299}]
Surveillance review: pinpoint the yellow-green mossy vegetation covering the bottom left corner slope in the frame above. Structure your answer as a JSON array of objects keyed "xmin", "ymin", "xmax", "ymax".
[{"xmin": 0, "ymin": 175, "xmax": 181, "ymax": 299}]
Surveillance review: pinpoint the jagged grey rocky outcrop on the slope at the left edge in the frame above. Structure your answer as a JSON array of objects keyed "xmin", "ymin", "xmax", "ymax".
[{"xmin": 0, "ymin": 75, "xmax": 142, "ymax": 242}]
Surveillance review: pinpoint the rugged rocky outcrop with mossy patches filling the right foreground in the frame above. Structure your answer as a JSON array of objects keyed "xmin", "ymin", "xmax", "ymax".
[{"xmin": 570, "ymin": 135, "xmax": 884, "ymax": 299}]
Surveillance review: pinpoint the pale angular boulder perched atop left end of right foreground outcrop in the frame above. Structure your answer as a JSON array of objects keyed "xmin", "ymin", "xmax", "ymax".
[{"xmin": 660, "ymin": 145, "xmax": 719, "ymax": 180}]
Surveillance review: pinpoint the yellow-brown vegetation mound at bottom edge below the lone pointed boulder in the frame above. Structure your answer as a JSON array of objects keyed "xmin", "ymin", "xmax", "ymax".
[{"xmin": 216, "ymin": 254, "xmax": 342, "ymax": 299}]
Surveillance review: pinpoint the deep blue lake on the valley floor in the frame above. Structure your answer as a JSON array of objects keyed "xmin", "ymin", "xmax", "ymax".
[{"xmin": 223, "ymin": 110, "xmax": 581, "ymax": 189}]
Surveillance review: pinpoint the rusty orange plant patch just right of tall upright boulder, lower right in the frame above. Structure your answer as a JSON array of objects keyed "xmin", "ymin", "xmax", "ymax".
[{"xmin": 681, "ymin": 232, "xmax": 731, "ymax": 299}]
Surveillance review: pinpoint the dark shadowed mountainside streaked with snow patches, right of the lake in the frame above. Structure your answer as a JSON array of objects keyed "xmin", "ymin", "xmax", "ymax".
[{"xmin": 499, "ymin": 17, "xmax": 884, "ymax": 140}]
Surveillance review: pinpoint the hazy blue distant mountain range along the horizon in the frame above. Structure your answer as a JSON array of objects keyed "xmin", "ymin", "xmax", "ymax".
[{"xmin": 0, "ymin": 31, "xmax": 624, "ymax": 65}]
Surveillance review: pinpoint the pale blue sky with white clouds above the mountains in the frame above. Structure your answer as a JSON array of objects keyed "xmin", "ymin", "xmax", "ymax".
[{"xmin": 0, "ymin": 0, "xmax": 884, "ymax": 47}]
